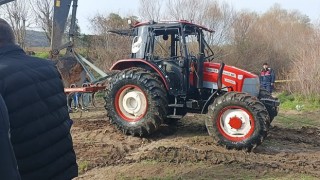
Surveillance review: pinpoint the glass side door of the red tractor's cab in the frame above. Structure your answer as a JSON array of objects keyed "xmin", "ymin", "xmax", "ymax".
[{"xmin": 147, "ymin": 28, "xmax": 188, "ymax": 96}]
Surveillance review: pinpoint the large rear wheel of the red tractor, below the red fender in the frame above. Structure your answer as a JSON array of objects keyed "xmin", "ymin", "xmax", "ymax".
[{"xmin": 105, "ymin": 68, "xmax": 168, "ymax": 136}]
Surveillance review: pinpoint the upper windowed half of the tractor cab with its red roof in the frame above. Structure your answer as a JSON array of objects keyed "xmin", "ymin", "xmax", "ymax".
[{"xmin": 132, "ymin": 21, "xmax": 213, "ymax": 60}]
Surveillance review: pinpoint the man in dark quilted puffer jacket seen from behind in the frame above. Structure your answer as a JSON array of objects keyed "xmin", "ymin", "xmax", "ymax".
[{"xmin": 0, "ymin": 19, "xmax": 78, "ymax": 180}]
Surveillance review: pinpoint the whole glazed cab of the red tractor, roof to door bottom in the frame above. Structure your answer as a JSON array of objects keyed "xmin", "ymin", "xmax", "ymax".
[{"xmin": 114, "ymin": 21, "xmax": 214, "ymax": 96}]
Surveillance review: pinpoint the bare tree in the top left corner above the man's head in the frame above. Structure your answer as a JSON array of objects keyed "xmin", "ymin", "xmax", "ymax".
[{"xmin": 3, "ymin": 0, "xmax": 30, "ymax": 48}]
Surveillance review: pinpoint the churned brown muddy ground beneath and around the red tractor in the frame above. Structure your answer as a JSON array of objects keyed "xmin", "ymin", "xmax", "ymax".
[{"xmin": 71, "ymin": 103, "xmax": 320, "ymax": 180}]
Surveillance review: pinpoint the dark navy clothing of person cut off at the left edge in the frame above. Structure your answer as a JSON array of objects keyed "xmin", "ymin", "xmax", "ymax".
[{"xmin": 0, "ymin": 94, "xmax": 21, "ymax": 180}]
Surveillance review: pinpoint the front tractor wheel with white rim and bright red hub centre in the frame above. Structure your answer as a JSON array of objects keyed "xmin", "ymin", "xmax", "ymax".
[{"xmin": 206, "ymin": 92, "xmax": 270, "ymax": 151}]
